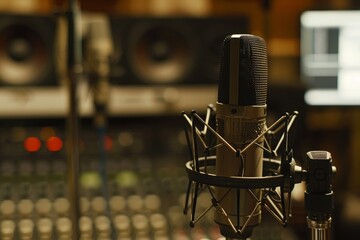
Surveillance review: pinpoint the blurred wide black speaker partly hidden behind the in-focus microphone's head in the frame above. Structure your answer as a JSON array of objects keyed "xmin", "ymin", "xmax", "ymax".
[{"xmin": 110, "ymin": 16, "xmax": 249, "ymax": 85}]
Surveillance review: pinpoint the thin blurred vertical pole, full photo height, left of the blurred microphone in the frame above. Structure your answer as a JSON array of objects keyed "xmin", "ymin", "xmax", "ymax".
[{"xmin": 67, "ymin": 0, "xmax": 82, "ymax": 240}]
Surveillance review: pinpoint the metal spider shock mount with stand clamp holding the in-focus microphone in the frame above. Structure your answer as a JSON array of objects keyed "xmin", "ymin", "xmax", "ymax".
[{"xmin": 182, "ymin": 108, "xmax": 336, "ymax": 240}]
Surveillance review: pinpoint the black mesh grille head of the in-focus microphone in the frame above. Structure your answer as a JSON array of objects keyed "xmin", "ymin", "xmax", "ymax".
[{"xmin": 218, "ymin": 34, "xmax": 268, "ymax": 106}]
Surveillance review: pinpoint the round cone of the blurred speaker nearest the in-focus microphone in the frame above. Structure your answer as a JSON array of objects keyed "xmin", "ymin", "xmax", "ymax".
[{"xmin": 128, "ymin": 26, "xmax": 195, "ymax": 84}]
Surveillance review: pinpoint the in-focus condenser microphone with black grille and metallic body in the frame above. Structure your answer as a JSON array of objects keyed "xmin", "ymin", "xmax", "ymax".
[{"xmin": 214, "ymin": 34, "xmax": 268, "ymax": 239}]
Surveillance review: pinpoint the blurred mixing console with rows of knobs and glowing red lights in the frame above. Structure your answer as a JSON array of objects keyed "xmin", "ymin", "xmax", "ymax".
[{"xmin": 0, "ymin": 117, "xmax": 296, "ymax": 240}]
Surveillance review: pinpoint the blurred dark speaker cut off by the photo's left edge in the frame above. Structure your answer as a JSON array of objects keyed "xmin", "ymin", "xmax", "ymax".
[{"xmin": 0, "ymin": 14, "xmax": 57, "ymax": 87}]
